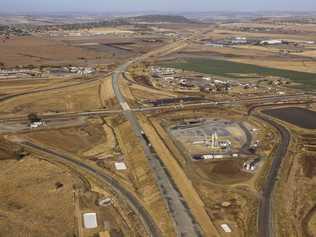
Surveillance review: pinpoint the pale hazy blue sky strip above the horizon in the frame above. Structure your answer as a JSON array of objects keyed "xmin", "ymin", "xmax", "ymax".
[{"xmin": 0, "ymin": 0, "xmax": 316, "ymax": 12}]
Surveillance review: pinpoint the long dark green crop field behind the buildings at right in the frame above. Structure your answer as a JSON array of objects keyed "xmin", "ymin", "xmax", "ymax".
[{"xmin": 163, "ymin": 58, "xmax": 316, "ymax": 90}]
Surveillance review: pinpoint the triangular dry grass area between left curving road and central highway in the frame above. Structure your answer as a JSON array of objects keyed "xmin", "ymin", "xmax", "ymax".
[{"xmin": 23, "ymin": 115, "xmax": 174, "ymax": 237}]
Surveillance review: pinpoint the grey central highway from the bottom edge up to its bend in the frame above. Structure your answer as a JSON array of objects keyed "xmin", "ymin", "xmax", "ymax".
[{"xmin": 112, "ymin": 61, "xmax": 201, "ymax": 237}]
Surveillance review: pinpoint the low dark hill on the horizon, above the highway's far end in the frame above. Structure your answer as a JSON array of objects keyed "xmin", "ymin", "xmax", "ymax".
[{"xmin": 128, "ymin": 15, "xmax": 197, "ymax": 24}]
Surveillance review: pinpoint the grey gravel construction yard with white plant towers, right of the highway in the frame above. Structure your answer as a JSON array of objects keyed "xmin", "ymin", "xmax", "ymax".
[{"xmin": 169, "ymin": 119, "xmax": 252, "ymax": 160}]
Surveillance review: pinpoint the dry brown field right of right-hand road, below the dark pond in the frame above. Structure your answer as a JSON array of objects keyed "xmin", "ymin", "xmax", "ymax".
[{"xmin": 274, "ymin": 118, "xmax": 316, "ymax": 237}]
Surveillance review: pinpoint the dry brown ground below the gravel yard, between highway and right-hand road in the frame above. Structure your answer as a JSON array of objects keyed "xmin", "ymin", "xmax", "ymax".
[{"xmin": 193, "ymin": 181, "xmax": 259, "ymax": 237}]
